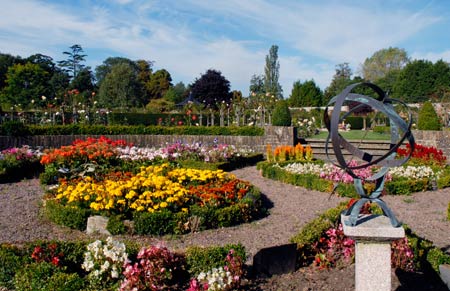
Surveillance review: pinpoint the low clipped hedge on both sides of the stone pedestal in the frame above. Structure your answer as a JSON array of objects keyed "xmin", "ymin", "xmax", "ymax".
[{"xmin": 290, "ymin": 202, "xmax": 450, "ymax": 274}]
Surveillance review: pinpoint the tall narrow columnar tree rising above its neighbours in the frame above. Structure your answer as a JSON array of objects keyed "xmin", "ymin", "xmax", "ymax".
[{"xmin": 264, "ymin": 45, "xmax": 283, "ymax": 98}]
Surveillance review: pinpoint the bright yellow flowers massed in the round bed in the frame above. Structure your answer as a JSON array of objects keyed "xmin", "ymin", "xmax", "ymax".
[{"xmin": 55, "ymin": 164, "xmax": 235, "ymax": 213}]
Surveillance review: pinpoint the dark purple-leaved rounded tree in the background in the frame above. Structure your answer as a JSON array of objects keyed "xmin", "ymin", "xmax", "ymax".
[{"xmin": 191, "ymin": 69, "xmax": 232, "ymax": 109}]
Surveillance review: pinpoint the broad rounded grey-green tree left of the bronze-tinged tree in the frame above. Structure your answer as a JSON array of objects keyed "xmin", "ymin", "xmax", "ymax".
[{"xmin": 99, "ymin": 63, "xmax": 142, "ymax": 108}]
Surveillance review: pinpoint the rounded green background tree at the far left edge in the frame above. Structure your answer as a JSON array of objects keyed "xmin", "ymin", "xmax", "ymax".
[{"xmin": 2, "ymin": 62, "xmax": 49, "ymax": 108}]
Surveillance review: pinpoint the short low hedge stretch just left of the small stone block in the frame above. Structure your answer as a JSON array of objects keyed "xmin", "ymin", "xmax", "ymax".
[{"xmin": 45, "ymin": 200, "xmax": 90, "ymax": 230}]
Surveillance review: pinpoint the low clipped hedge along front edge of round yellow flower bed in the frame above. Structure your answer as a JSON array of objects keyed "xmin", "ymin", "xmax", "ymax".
[{"xmin": 44, "ymin": 186, "xmax": 267, "ymax": 235}]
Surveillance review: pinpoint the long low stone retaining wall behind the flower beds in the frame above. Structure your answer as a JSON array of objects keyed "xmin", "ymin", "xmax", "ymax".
[{"xmin": 0, "ymin": 126, "xmax": 297, "ymax": 153}]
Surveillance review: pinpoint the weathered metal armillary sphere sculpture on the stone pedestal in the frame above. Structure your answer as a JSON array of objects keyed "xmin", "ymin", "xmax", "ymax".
[{"xmin": 324, "ymin": 83, "xmax": 415, "ymax": 227}]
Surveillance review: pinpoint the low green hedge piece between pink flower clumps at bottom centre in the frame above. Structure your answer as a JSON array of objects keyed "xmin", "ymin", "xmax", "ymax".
[{"xmin": 185, "ymin": 244, "xmax": 246, "ymax": 276}]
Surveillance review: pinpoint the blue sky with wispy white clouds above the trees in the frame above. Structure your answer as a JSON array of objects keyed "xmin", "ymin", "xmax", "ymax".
[{"xmin": 0, "ymin": 0, "xmax": 450, "ymax": 98}]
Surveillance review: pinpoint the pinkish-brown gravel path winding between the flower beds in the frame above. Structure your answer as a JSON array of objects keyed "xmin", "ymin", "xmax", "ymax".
[{"xmin": 0, "ymin": 166, "xmax": 450, "ymax": 290}]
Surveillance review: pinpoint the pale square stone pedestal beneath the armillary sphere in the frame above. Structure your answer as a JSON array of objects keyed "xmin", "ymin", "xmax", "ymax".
[{"xmin": 341, "ymin": 215, "xmax": 405, "ymax": 291}]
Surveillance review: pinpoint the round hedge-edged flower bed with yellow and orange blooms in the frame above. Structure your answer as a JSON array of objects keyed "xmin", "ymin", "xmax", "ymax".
[{"xmin": 41, "ymin": 138, "xmax": 264, "ymax": 235}]
